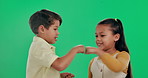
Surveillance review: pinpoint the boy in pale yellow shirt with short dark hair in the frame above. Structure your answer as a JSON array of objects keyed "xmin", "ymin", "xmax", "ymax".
[{"xmin": 26, "ymin": 9, "xmax": 84, "ymax": 78}]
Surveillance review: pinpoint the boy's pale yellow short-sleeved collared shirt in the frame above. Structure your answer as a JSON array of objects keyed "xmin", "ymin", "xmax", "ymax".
[{"xmin": 26, "ymin": 36, "xmax": 60, "ymax": 78}]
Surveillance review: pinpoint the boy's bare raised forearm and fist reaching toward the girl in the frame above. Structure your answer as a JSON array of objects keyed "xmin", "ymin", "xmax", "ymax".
[{"xmin": 51, "ymin": 45, "xmax": 84, "ymax": 71}]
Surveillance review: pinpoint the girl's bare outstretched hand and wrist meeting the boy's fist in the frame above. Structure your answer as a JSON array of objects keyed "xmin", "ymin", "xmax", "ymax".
[{"xmin": 85, "ymin": 47, "xmax": 104, "ymax": 56}]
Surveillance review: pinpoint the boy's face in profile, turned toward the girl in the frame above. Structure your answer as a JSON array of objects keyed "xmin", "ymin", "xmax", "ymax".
[{"xmin": 39, "ymin": 20, "xmax": 60, "ymax": 44}]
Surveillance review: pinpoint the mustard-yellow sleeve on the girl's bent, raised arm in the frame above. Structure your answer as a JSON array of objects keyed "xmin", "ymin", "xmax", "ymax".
[{"xmin": 100, "ymin": 51, "xmax": 130, "ymax": 72}]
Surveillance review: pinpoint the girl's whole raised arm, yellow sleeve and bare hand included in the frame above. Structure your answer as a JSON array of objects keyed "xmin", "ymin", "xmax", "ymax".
[{"xmin": 86, "ymin": 47, "xmax": 130, "ymax": 72}]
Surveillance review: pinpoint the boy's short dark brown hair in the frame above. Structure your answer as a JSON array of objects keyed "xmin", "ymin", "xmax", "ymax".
[{"xmin": 29, "ymin": 9, "xmax": 62, "ymax": 34}]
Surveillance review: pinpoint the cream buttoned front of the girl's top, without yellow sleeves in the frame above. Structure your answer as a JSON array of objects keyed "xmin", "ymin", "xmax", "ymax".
[{"xmin": 90, "ymin": 53, "xmax": 126, "ymax": 78}]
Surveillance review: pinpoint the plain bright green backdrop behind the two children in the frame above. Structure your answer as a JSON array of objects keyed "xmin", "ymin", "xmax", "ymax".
[{"xmin": 0, "ymin": 0, "xmax": 148, "ymax": 78}]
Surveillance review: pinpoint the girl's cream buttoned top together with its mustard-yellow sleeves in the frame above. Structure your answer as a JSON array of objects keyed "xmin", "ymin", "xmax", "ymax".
[{"xmin": 89, "ymin": 51, "xmax": 130, "ymax": 78}]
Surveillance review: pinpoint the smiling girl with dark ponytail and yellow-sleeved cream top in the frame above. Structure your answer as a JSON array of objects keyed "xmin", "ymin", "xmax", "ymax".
[{"xmin": 86, "ymin": 19, "xmax": 132, "ymax": 78}]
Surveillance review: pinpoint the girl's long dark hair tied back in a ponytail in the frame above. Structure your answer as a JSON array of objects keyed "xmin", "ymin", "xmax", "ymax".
[{"xmin": 98, "ymin": 18, "xmax": 133, "ymax": 78}]
